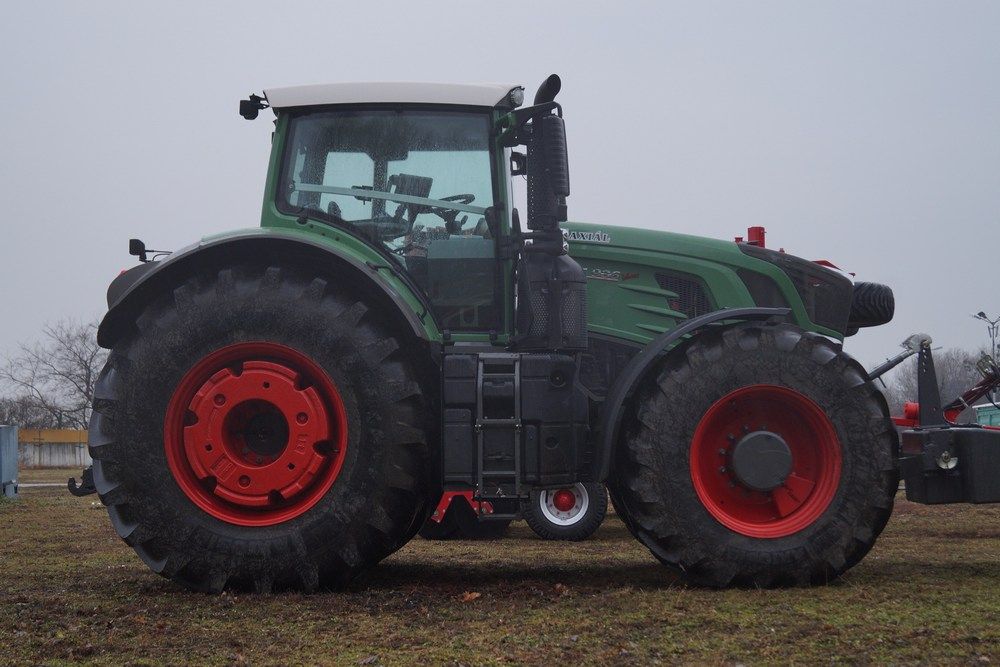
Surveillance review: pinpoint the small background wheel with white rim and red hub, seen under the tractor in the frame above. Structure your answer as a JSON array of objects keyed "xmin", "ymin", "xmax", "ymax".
[{"xmin": 522, "ymin": 483, "xmax": 608, "ymax": 542}]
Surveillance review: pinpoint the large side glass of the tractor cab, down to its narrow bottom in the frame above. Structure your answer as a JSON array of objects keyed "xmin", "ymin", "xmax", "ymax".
[{"xmin": 278, "ymin": 109, "xmax": 502, "ymax": 331}]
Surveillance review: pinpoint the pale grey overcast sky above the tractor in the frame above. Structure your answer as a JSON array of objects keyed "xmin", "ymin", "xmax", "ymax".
[{"xmin": 0, "ymin": 0, "xmax": 1000, "ymax": 365}]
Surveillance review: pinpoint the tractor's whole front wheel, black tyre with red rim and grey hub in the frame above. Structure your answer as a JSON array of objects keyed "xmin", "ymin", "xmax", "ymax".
[{"xmin": 610, "ymin": 324, "xmax": 898, "ymax": 587}]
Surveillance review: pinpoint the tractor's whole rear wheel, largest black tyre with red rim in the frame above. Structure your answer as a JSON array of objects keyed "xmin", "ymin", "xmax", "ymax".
[{"xmin": 89, "ymin": 266, "xmax": 432, "ymax": 592}]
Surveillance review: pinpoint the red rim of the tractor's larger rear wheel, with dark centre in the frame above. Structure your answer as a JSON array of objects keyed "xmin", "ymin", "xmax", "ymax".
[{"xmin": 163, "ymin": 342, "xmax": 347, "ymax": 526}]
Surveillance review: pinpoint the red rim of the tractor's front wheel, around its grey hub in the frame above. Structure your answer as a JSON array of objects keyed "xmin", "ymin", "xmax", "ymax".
[{"xmin": 690, "ymin": 385, "xmax": 841, "ymax": 538}]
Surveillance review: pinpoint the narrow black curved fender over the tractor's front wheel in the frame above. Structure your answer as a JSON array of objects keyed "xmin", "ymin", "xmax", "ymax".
[{"xmin": 597, "ymin": 308, "xmax": 791, "ymax": 481}]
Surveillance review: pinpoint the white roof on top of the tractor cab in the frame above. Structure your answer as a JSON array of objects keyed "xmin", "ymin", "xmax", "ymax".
[{"xmin": 264, "ymin": 81, "xmax": 520, "ymax": 109}]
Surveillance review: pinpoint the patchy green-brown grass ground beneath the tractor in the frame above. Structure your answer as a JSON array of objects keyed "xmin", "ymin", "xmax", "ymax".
[{"xmin": 0, "ymin": 471, "xmax": 1000, "ymax": 665}]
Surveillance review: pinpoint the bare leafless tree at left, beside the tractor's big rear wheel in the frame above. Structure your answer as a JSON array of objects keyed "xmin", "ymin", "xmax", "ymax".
[{"xmin": 0, "ymin": 320, "xmax": 107, "ymax": 428}]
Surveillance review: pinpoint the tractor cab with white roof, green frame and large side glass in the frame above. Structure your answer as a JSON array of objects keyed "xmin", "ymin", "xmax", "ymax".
[{"xmin": 260, "ymin": 83, "xmax": 523, "ymax": 334}]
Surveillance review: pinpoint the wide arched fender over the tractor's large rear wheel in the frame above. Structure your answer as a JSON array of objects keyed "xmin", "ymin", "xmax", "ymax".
[{"xmin": 97, "ymin": 228, "xmax": 438, "ymax": 349}]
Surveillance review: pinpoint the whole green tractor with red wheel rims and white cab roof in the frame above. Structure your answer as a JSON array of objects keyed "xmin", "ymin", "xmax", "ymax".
[{"xmin": 76, "ymin": 76, "xmax": 1000, "ymax": 591}]
